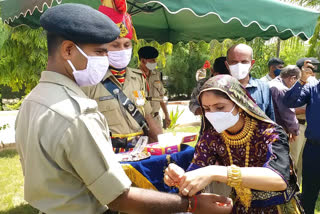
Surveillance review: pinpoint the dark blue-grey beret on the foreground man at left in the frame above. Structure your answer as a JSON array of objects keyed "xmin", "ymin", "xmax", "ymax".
[{"xmin": 40, "ymin": 4, "xmax": 120, "ymax": 44}]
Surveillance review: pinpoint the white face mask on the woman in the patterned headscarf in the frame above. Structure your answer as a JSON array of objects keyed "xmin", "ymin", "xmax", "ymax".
[{"xmin": 205, "ymin": 105, "xmax": 239, "ymax": 133}]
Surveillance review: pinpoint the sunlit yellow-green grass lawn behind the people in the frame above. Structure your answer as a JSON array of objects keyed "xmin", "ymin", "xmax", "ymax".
[{"xmin": 0, "ymin": 127, "xmax": 320, "ymax": 214}]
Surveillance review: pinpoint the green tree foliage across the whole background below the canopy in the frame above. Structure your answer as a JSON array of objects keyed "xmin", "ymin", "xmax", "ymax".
[{"xmin": 0, "ymin": 14, "xmax": 312, "ymax": 100}]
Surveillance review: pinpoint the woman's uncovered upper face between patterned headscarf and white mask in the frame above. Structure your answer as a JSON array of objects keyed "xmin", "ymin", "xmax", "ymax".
[{"xmin": 201, "ymin": 91, "xmax": 239, "ymax": 115}]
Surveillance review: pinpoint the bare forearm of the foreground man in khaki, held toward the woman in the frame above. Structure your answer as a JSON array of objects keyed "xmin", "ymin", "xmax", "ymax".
[{"xmin": 108, "ymin": 187, "xmax": 189, "ymax": 214}]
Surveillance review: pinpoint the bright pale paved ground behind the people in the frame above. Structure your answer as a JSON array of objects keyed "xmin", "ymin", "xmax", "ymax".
[{"xmin": 0, "ymin": 101, "xmax": 200, "ymax": 144}]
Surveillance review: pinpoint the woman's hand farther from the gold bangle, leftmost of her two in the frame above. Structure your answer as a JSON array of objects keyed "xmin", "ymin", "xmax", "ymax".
[{"xmin": 164, "ymin": 163, "xmax": 185, "ymax": 186}]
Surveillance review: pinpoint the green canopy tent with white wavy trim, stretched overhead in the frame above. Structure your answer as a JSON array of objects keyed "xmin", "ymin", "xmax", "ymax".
[{"xmin": 0, "ymin": 0, "xmax": 319, "ymax": 43}]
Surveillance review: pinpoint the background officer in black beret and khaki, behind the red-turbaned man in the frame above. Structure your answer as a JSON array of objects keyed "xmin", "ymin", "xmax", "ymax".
[{"xmin": 138, "ymin": 46, "xmax": 171, "ymax": 127}]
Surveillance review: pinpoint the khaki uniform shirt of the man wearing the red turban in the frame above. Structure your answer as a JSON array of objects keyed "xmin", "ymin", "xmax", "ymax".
[{"xmin": 82, "ymin": 68, "xmax": 151, "ymax": 134}]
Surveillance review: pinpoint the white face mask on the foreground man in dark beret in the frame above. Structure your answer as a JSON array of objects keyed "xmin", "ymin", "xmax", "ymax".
[{"xmin": 67, "ymin": 46, "xmax": 109, "ymax": 86}]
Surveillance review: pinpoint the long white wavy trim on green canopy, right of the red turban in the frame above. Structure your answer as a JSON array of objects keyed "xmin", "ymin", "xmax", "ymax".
[{"xmin": 144, "ymin": 1, "xmax": 312, "ymax": 39}]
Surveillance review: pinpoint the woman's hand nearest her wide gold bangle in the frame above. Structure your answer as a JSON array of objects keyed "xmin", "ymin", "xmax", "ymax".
[{"xmin": 179, "ymin": 166, "xmax": 213, "ymax": 196}]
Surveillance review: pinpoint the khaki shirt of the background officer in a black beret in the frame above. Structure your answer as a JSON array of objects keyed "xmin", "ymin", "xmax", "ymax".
[{"xmin": 147, "ymin": 71, "xmax": 166, "ymax": 114}]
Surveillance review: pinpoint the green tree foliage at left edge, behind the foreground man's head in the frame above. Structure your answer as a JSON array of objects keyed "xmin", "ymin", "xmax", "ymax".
[{"xmin": 0, "ymin": 26, "xmax": 47, "ymax": 92}]
